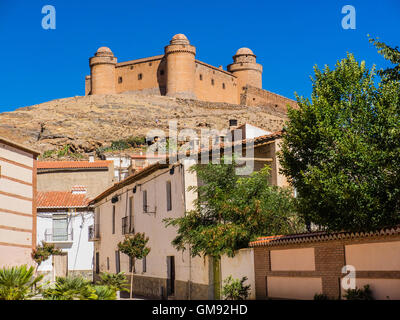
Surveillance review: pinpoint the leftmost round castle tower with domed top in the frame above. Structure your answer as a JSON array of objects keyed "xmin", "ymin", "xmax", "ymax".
[{"xmin": 89, "ymin": 47, "xmax": 117, "ymax": 94}]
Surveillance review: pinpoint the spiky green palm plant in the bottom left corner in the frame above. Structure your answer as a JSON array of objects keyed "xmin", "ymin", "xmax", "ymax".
[{"xmin": 0, "ymin": 265, "xmax": 43, "ymax": 300}]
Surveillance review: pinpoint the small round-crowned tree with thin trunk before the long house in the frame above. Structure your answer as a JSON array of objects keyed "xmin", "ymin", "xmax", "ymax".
[{"xmin": 118, "ymin": 232, "xmax": 151, "ymax": 298}]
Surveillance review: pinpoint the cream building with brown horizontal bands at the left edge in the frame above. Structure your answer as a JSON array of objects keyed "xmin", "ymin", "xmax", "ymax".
[{"xmin": 0, "ymin": 137, "xmax": 39, "ymax": 268}]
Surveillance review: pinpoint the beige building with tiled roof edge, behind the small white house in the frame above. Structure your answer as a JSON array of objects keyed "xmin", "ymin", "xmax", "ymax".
[{"xmin": 37, "ymin": 158, "xmax": 115, "ymax": 198}]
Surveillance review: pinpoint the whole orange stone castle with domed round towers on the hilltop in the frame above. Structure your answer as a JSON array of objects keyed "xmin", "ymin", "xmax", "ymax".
[{"xmin": 85, "ymin": 34, "xmax": 296, "ymax": 112}]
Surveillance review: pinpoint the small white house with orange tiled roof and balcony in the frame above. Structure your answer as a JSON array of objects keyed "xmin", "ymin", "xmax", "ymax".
[{"xmin": 37, "ymin": 186, "xmax": 93, "ymax": 280}]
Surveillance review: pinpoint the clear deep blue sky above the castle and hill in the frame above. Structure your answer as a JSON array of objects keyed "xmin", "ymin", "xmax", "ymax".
[{"xmin": 0, "ymin": 0, "xmax": 400, "ymax": 112}]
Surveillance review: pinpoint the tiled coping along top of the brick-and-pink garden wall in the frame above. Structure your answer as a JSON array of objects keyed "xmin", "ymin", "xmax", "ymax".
[{"xmin": 249, "ymin": 225, "xmax": 400, "ymax": 247}]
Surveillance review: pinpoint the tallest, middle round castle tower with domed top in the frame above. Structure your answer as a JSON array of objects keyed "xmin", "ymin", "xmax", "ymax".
[{"xmin": 164, "ymin": 34, "xmax": 196, "ymax": 98}]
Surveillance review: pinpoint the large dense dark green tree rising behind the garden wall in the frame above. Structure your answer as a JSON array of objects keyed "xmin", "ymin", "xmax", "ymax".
[{"xmin": 281, "ymin": 54, "xmax": 400, "ymax": 231}]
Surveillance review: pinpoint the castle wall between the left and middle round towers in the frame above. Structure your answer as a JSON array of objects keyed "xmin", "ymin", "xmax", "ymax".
[{"xmin": 115, "ymin": 55, "xmax": 166, "ymax": 95}]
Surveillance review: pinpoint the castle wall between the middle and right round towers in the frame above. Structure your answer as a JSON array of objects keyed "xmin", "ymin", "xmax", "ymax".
[{"xmin": 195, "ymin": 60, "xmax": 239, "ymax": 104}]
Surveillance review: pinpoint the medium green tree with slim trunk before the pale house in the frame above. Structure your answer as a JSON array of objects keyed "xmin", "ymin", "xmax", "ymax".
[{"xmin": 164, "ymin": 160, "xmax": 303, "ymax": 299}]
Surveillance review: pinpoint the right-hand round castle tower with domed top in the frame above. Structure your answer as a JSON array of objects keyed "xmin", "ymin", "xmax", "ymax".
[{"xmin": 228, "ymin": 48, "xmax": 262, "ymax": 89}]
